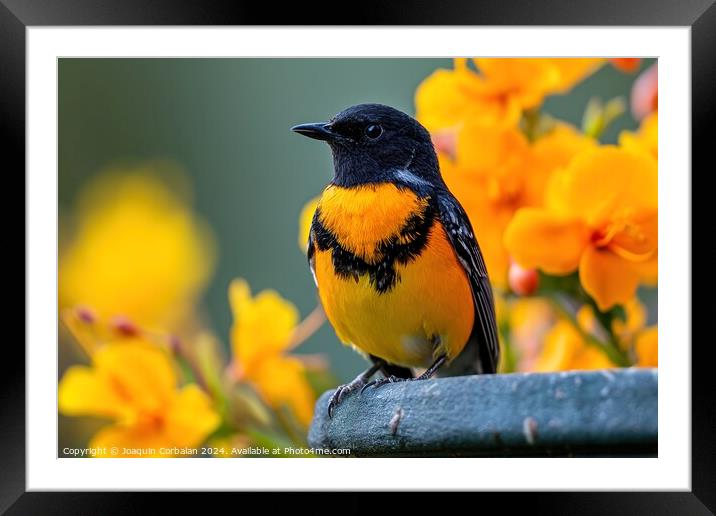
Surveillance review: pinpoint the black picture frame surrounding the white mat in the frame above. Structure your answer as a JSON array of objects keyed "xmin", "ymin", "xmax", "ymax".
[{"xmin": 0, "ymin": 0, "xmax": 716, "ymax": 514}]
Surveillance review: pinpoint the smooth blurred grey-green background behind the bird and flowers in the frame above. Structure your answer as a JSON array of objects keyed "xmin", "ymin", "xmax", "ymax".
[{"xmin": 59, "ymin": 59, "xmax": 653, "ymax": 381}]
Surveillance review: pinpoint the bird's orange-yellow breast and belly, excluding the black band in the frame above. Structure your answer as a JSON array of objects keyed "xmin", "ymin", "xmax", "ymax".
[{"xmin": 315, "ymin": 185, "xmax": 474, "ymax": 367}]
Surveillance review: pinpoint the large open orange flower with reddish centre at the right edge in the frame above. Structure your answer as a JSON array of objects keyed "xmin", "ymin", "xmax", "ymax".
[{"xmin": 504, "ymin": 146, "xmax": 658, "ymax": 310}]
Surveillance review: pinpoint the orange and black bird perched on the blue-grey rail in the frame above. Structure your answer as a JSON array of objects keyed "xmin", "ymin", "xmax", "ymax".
[{"xmin": 292, "ymin": 104, "xmax": 499, "ymax": 415}]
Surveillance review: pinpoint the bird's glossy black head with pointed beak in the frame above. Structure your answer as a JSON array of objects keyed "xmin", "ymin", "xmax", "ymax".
[{"xmin": 292, "ymin": 104, "xmax": 442, "ymax": 189}]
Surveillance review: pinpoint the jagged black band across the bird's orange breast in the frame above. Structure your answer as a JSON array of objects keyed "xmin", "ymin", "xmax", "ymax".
[{"xmin": 312, "ymin": 198, "xmax": 437, "ymax": 294}]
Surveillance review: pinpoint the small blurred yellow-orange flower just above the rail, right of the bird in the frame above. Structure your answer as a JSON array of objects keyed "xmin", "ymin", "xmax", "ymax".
[{"xmin": 534, "ymin": 321, "xmax": 614, "ymax": 372}]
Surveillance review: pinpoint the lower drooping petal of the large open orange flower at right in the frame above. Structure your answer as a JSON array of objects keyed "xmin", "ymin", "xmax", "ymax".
[{"xmin": 579, "ymin": 246, "xmax": 639, "ymax": 311}]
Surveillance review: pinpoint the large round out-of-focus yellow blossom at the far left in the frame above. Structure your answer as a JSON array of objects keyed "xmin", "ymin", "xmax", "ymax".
[{"xmin": 59, "ymin": 166, "xmax": 214, "ymax": 328}]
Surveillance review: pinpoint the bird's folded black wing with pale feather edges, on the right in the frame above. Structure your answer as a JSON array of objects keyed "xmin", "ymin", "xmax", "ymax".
[{"xmin": 437, "ymin": 190, "xmax": 500, "ymax": 373}]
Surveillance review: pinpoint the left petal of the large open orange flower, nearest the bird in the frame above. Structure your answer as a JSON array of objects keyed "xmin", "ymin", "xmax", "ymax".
[{"xmin": 504, "ymin": 208, "xmax": 588, "ymax": 274}]
